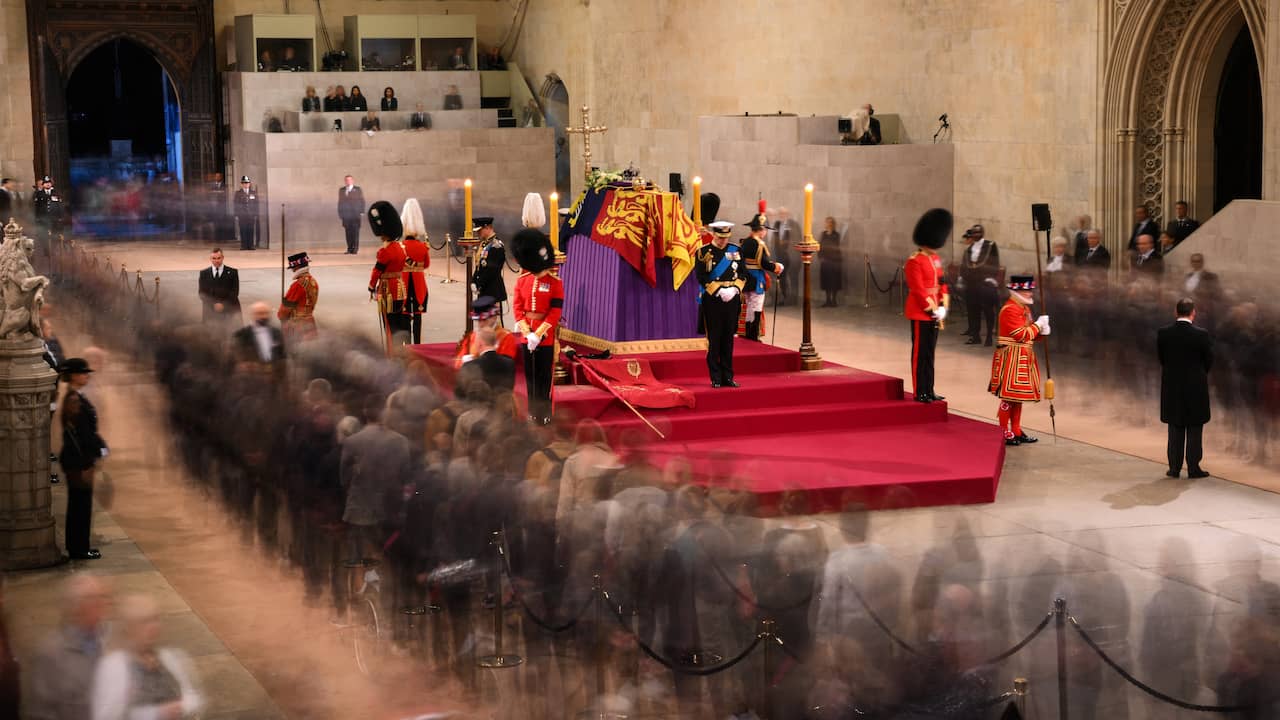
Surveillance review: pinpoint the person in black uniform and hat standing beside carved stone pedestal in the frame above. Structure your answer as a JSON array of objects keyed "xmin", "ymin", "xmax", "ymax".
[{"xmin": 58, "ymin": 357, "xmax": 106, "ymax": 560}]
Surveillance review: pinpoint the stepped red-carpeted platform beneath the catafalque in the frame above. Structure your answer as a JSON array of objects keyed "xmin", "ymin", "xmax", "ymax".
[{"xmin": 413, "ymin": 341, "xmax": 1005, "ymax": 511}]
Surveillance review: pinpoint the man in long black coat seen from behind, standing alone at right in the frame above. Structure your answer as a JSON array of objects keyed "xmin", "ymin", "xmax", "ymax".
[{"xmin": 1156, "ymin": 297, "xmax": 1213, "ymax": 478}]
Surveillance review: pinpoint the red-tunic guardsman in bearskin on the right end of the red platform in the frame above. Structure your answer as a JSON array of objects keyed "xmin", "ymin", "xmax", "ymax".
[{"xmin": 902, "ymin": 208, "xmax": 952, "ymax": 402}]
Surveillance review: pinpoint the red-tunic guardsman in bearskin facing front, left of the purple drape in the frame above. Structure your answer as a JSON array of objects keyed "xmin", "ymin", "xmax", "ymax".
[{"xmin": 511, "ymin": 228, "xmax": 564, "ymax": 425}]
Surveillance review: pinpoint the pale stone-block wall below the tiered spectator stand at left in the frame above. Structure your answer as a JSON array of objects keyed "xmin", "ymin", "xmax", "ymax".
[{"xmin": 237, "ymin": 128, "xmax": 556, "ymax": 250}]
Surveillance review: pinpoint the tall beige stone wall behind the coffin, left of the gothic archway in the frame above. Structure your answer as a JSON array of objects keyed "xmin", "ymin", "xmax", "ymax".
[{"xmin": 516, "ymin": 0, "xmax": 1098, "ymax": 274}]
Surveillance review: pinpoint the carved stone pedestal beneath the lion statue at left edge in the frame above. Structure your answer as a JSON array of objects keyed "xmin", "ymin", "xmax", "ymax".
[{"xmin": 0, "ymin": 338, "xmax": 64, "ymax": 570}]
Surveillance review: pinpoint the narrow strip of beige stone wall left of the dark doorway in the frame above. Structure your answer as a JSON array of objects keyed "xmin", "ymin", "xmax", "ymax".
[{"xmin": 0, "ymin": 0, "xmax": 35, "ymax": 190}]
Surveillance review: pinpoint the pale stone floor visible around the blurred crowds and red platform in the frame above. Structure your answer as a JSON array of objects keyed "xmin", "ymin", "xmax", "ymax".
[{"xmin": 15, "ymin": 238, "xmax": 1280, "ymax": 717}]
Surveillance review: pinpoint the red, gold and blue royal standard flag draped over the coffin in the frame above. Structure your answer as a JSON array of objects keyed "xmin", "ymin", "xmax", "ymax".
[{"xmin": 561, "ymin": 183, "xmax": 701, "ymax": 290}]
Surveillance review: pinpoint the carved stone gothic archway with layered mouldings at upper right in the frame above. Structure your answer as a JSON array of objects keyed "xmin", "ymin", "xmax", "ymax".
[{"xmin": 1098, "ymin": 0, "xmax": 1266, "ymax": 251}]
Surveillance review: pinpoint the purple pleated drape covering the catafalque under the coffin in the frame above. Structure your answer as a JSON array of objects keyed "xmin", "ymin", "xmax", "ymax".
[{"xmin": 561, "ymin": 234, "xmax": 699, "ymax": 342}]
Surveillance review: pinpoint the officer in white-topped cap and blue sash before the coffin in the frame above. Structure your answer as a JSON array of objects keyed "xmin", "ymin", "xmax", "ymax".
[{"xmin": 694, "ymin": 220, "xmax": 746, "ymax": 387}]
